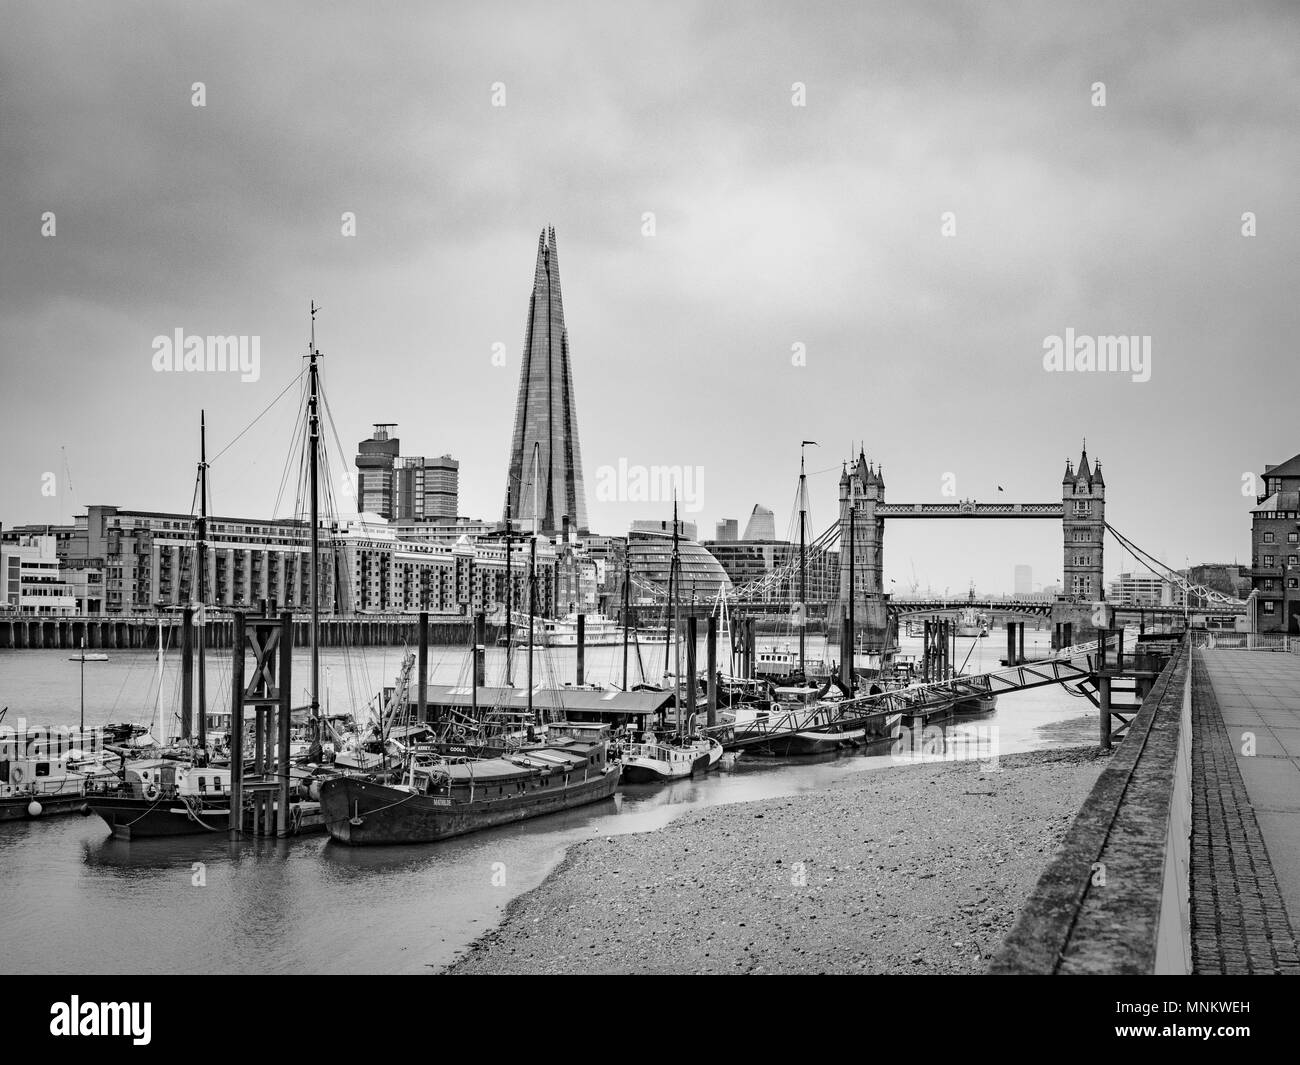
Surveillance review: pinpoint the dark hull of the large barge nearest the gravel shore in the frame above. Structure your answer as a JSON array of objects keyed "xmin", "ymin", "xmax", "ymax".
[{"xmin": 320, "ymin": 766, "xmax": 619, "ymax": 847}]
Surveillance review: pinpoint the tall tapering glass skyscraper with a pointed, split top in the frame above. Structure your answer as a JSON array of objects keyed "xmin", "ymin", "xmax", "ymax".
[{"xmin": 506, "ymin": 226, "xmax": 588, "ymax": 536}]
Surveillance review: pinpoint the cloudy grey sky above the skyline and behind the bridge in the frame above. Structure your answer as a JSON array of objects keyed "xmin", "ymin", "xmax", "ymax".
[{"xmin": 0, "ymin": 0, "xmax": 1300, "ymax": 590}]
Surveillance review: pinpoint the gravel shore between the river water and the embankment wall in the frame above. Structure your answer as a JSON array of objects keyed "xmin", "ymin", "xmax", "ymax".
[{"xmin": 445, "ymin": 748, "xmax": 1105, "ymax": 974}]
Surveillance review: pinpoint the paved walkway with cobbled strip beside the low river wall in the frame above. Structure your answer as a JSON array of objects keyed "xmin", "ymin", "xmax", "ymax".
[{"xmin": 1191, "ymin": 650, "xmax": 1300, "ymax": 974}]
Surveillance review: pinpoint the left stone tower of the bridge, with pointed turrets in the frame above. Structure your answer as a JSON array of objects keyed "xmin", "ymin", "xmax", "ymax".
[{"xmin": 829, "ymin": 449, "xmax": 889, "ymax": 648}]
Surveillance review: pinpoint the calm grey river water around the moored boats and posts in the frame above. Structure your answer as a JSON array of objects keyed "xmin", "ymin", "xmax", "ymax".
[{"xmin": 0, "ymin": 631, "xmax": 1096, "ymax": 974}]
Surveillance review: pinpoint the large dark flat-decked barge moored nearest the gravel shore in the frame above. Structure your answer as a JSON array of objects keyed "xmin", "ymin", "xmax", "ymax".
[{"xmin": 320, "ymin": 723, "xmax": 619, "ymax": 847}]
